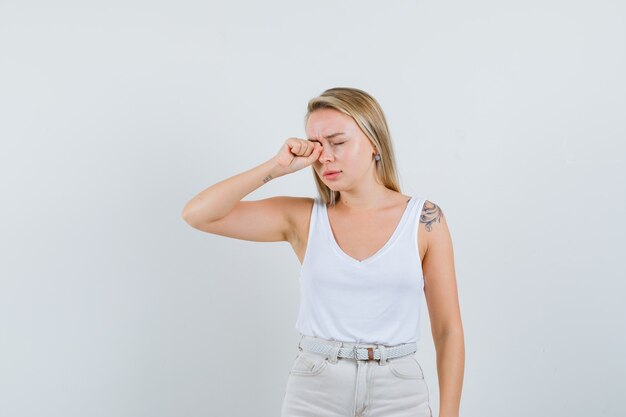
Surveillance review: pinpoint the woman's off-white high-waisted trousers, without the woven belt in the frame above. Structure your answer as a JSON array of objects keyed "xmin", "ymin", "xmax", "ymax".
[{"xmin": 281, "ymin": 335, "xmax": 432, "ymax": 417}]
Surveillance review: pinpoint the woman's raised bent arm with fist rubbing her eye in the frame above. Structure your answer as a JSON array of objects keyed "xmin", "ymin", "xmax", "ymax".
[{"xmin": 182, "ymin": 138, "xmax": 322, "ymax": 242}]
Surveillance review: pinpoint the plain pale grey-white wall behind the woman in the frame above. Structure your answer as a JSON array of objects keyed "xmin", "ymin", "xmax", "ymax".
[{"xmin": 0, "ymin": 0, "xmax": 626, "ymax": 417}]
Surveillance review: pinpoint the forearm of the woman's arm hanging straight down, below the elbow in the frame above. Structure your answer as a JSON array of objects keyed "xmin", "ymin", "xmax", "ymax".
[{"xmin": 435, "ymin": 330, "xmax": 465, "ymax": 417}]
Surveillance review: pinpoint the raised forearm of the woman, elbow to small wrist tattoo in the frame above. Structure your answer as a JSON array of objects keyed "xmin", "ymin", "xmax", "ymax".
[{"xmin": 182, "ymin": 158, "xmax": 284, "ymax": 224}]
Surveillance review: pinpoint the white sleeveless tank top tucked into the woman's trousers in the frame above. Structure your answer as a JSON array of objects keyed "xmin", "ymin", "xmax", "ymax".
[{"xmin": 295, "ymin": 197, "xmax": 426, "ymax": 345}]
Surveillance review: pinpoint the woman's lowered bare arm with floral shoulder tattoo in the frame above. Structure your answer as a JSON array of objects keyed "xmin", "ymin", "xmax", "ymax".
[{"xmin": 419, "ymin": 200, "xmax": 465, "ymax": 417}]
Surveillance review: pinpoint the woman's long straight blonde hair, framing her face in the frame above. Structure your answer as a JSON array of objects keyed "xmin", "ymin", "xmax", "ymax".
[{"xmin": 304, "ymin": 87, "xmax": 400, "ymax": 205}]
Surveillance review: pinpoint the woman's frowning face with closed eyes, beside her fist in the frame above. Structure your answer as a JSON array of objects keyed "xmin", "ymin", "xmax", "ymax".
[{"xmin": 306, "ymin": 109, "xmax": 375, "ymax": 190}]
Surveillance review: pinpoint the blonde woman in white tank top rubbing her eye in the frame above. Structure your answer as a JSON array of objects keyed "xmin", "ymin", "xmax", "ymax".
[{"xmin": 183, "ymin": 88, "xmax": 465, "ymax": 417}]
